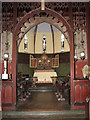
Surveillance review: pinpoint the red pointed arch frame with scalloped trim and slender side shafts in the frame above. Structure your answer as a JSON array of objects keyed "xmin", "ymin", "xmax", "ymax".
[{"xmin": 12, "ymin": 8, "xmax": 74, "ymax": 104}]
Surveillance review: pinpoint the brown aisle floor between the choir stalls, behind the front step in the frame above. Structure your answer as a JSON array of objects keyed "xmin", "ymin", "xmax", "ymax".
[{"xmin": 17, "ymin": 92, "xmax": 70, "ymax": 111}]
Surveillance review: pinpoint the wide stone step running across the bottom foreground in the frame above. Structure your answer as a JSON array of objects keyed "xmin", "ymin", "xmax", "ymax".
[{"xmin": 2, "ymin": 110, "xmax": 85, "ymax": 120}]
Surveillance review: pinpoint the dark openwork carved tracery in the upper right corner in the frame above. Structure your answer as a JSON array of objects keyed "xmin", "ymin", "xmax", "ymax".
[{"xmin": 72, "ymin": 2, "xmax": 86, "ymax": 31}]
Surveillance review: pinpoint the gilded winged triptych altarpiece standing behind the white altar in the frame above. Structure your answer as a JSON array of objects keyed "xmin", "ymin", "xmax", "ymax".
[{"xmin": 30, "ymin": 54, "xmax": 59, "ymax": 69}]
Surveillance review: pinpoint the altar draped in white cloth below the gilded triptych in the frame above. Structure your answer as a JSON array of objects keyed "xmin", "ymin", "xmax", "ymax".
[{"xmin": 33, "ymin": 70, "xmax": 57, "ymax": 83}]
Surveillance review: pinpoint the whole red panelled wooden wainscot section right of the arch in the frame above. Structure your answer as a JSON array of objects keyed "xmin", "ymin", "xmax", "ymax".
[{"xmin": 73, "ymin": 80, "xmax": 90, "ymax": 109}]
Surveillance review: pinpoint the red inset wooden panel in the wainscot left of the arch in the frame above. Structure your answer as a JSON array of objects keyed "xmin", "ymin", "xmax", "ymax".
[{"xmin": 5, "ymin": 86, "xmax": 12, "ymax": 103}]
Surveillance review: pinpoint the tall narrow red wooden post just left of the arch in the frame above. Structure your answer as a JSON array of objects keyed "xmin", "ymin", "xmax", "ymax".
[{"xmin": 12, "ymin": 3, "xmax": 17, "ymax": 105}]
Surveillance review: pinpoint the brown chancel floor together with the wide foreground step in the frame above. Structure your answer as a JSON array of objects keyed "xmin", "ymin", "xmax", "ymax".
[{"xmin": 2, "ymin": 92, "xmax": 85, "ymax": 120}]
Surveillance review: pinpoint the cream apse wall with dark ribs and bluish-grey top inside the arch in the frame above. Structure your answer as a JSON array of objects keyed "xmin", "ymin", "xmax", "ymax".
[{"xmin": 18, "ymin": 22, "xmax": 70, "ymax": 54}]
